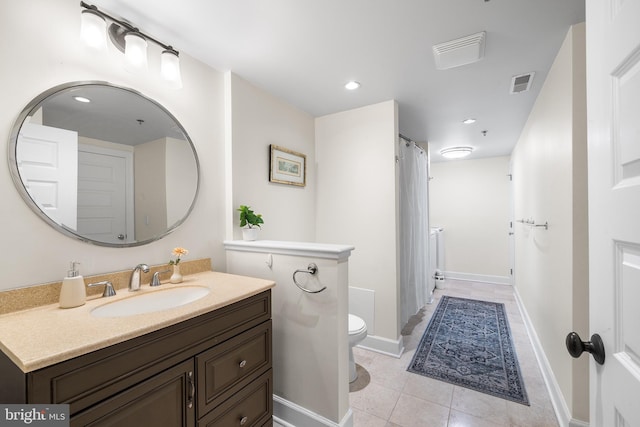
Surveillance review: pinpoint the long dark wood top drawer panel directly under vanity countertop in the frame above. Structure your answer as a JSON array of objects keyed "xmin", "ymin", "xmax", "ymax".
[{"xmin": 27, "ymin": 291, "xmax": 271, "ymax": 415}]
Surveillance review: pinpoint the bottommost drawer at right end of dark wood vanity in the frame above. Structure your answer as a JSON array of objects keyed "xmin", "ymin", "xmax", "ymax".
[{"xmin": 198, "ymin": 369, "xmax": 273, "ymax": 427}]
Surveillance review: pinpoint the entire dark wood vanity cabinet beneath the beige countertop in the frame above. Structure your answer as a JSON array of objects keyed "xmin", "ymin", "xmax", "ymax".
[{"xmin": 0, "ymin": 291, "xmax": 273, "ymax": 427}]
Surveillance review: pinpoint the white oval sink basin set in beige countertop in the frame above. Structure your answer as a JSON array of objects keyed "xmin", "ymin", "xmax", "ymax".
[{"xmin": 91, "ymin": 286, "xmax": 210, "ymax": 317}]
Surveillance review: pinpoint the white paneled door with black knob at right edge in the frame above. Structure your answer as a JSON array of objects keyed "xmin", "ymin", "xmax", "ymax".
[{"xmin": 582, "ymin": 0, "xmax": 640, "ymax": 427}]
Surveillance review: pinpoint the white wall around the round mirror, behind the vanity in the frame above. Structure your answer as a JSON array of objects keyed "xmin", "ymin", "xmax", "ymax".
[{"xmin": 0, "ymin": 0, "xmax": 225, "ymax": 290}]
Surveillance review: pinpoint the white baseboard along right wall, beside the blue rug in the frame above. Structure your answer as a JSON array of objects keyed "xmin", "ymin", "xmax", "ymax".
[{"xmin": 514, "ymin": 288, "xmax": 589, "ymax": 427}]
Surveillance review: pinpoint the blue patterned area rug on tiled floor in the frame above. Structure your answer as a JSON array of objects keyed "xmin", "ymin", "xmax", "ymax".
[{"xmin": 407, "ymin": 296, "xmax": 529, "ymax": 405}]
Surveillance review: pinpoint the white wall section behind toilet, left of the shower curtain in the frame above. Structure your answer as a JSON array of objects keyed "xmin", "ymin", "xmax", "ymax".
[{"xmin": 316, "ymin": 101, "xmax": 400, "ymax": 350}]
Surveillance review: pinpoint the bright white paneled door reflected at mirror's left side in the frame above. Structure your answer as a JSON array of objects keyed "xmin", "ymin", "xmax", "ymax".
[{"xmin": 16, "ymin": 123, "xmax": 78, "ymax": 230}]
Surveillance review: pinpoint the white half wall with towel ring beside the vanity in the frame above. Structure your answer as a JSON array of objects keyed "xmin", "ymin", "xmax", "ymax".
[{"xmin": 227, "ymin": 244, "xmax": 351, "ymax": 426}]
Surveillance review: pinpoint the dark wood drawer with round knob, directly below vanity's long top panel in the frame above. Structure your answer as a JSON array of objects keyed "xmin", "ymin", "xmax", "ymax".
[{"xmin": 196, "ymin": 320, "xmax": 271, "ymax": 416}]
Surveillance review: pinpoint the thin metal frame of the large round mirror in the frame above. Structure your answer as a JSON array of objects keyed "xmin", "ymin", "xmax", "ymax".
[{"xmin": 7, "ymin": 80, "xmax": 200, "ymax": 248}]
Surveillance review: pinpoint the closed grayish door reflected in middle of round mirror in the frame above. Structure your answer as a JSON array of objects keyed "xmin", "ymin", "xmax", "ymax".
[{"xmin": 78, "ymin": 144, "xmax": 134, "ymax": 243}]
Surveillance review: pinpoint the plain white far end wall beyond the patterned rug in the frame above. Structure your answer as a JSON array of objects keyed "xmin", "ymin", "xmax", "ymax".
[{"xmin": 429, "ymin": 157, "xmax": 510, "ymax": 282}]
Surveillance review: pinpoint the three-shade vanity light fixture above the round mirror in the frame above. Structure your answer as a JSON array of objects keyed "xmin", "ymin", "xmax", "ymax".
[{"xmin": 80, "ymin": 1, "xmax": 182, "ymax": 88}]
